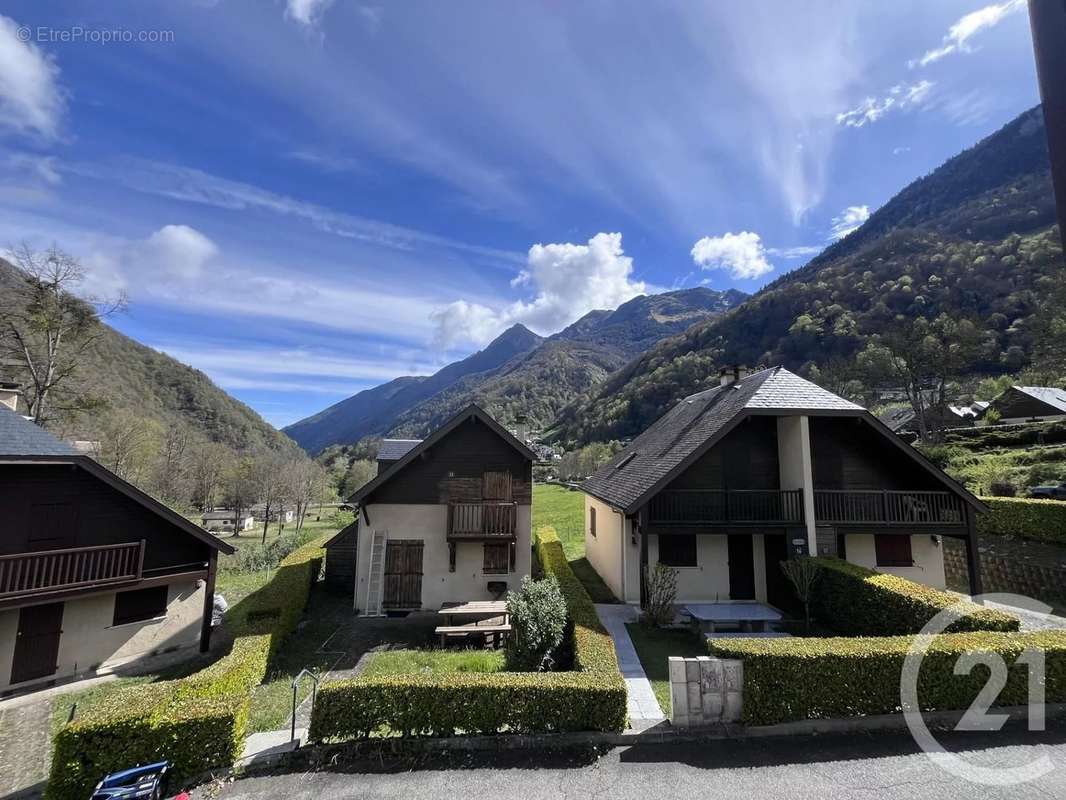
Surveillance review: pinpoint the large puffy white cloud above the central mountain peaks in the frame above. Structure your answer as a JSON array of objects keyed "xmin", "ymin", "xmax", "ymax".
[{"xmin": 432, "ymin": 228, "xmax": 648, "ymax": 348}]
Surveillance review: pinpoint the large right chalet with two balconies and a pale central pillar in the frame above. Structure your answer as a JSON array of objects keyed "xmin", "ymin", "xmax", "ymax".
[{"xmin": 582, "ymin": 367, "xmax": 984, "ymax": 606}]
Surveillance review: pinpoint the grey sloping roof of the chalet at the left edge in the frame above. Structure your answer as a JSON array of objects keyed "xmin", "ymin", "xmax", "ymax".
[{"xmin": 0, "ymin": 409, "xmax": 233, "ymax": 553}]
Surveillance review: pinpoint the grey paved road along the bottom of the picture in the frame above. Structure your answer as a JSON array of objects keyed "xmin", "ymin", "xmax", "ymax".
[{"xmin": 197, "ymin": 729, "xmax": 1066, "ymax": 800}]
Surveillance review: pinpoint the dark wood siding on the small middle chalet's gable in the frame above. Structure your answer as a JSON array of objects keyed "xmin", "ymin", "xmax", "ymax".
[{"xmin": 366, "ymin": 419, "xmax": 533, "ymax": 505}]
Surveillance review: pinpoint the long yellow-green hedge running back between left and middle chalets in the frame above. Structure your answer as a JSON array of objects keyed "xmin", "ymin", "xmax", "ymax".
[{"xmin": 46, "ymin": 538, "xmax": 325, "ymax": 800}]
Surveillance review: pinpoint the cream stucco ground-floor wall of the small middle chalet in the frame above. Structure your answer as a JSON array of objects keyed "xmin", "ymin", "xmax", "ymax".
[{"xmin": 355, "ymin": 503, "xmax": 532, "ymax": 611}]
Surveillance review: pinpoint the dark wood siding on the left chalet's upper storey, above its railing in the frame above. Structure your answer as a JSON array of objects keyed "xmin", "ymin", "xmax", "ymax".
[{"xmin": 0, "ymin": 464, "xmax": 211, "ymax": 575}]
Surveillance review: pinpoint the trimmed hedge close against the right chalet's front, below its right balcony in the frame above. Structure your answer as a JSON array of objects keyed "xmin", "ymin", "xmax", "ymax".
[{"xmin": 810, "ymin": 557, "xmax": 1018, "ymax": 636}]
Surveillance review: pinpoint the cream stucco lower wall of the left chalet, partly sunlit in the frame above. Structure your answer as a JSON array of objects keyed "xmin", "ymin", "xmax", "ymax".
[{"xmin": 0, "ymin": 582, "xmax": 204, "ymax": 689}]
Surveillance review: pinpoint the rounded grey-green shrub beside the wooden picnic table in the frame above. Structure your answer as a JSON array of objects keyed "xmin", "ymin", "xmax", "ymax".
[{"xmin": 506, "ymin": 575, "xmax": 566, "ymax": 672}]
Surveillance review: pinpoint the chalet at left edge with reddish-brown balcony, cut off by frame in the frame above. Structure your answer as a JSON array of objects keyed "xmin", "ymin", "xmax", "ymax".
[{"xmin": 0, "ymin": 409, "xmax": 232, "ymax": 691}]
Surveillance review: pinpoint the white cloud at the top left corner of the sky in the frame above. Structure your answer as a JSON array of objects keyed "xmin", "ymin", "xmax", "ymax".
[{"xmin": 0, "ymin": 16, "xmax": 66, "ymax": 139}]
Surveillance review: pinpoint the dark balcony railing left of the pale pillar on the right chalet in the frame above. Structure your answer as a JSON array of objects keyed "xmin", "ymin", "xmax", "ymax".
[{"xmin": 649, "ymin": 490, "xmax": 804, "ymax": 525}]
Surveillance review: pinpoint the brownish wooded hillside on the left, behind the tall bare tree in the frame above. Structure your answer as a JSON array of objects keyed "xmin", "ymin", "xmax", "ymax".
[{"xmin": 0, "ymin": 259, "xmax": 294, "ymax": 450}]
